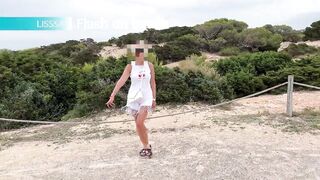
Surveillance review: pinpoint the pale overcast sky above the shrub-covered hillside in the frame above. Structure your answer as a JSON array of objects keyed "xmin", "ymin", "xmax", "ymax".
[{"xmin": 0, "ymin": 0, "xmax": 320, "ymax": 50}]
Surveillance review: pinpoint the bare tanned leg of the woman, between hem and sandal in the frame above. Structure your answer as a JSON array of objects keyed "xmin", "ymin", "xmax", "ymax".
[{"xmin": 135, "ymin": 107, "xmax": 149, "ymax": 148}]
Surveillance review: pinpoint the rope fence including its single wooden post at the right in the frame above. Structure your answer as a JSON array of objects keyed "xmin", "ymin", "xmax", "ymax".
[{"xmin": 0, "ymin": 76, "xmax": 320, "ymax": 124}]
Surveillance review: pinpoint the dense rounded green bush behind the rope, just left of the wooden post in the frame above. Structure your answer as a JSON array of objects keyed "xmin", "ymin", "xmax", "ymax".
[{"xmin": 214, "ymin": 52, "xmax": 292, "ymax": 97}]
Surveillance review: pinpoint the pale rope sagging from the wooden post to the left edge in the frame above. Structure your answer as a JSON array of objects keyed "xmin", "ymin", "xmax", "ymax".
[{"xmin": 0, "ymin": 82, "xmax": 288, "ymax": 124}]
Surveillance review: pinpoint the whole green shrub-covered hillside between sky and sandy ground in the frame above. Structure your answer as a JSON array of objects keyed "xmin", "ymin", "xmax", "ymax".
[{"xmin": 0, "ymin": 18, "xmax": 320, "ymax": 131}]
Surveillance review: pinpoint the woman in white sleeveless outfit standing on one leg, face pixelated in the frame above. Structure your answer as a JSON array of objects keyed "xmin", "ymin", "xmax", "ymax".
[{"xmin": 106, "ymin": 49, "xmax": 156, "ymax": 157}]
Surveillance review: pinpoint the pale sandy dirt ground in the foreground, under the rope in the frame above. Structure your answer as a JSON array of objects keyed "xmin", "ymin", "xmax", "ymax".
[{"xmin": 0, "ymin": 92, "xmax": 320, "ymax": 179}]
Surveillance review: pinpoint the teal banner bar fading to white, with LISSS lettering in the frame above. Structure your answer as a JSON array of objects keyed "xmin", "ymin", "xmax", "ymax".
[{"xmin": 0, "ymin": 17, "xmax": 68, "ymax": 30}]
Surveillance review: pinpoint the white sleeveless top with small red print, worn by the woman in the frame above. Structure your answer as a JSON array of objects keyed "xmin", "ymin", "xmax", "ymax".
[{"xmin": 127, "ymin": 60, "xmax": 153, "ymax": 106}]
